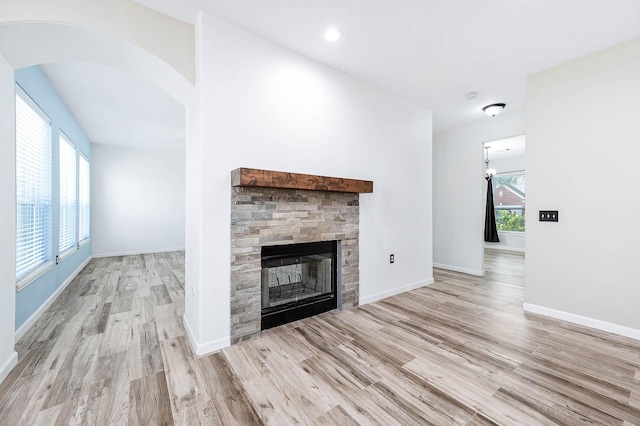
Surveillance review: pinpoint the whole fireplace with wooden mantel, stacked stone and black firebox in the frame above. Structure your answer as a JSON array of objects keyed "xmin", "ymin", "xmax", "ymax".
[{"xmin": 230, "ymin": 168, "xmax": 373, "ymax": 344}]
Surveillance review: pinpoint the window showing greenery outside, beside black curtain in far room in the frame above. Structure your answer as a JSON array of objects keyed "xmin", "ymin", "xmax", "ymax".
[{"xmin": 493, "ymin": 174, "xmax": 525, "ymax": 232}]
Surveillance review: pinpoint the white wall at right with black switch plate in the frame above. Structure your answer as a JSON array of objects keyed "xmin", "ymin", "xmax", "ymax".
[{"xmin": 525, "ymin": 39, "xmax": 640, "ymax": 338}]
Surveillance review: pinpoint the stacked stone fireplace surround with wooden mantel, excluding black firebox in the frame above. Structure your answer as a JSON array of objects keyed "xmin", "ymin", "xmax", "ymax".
[{"xmin": 231, "ymin": 168, "xmax": 373, "ymax": 344}]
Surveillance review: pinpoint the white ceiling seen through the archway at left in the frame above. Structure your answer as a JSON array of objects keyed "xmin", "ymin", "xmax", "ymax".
[{"xmin": 40, "ymin": 62, "xmax": 185, "ymax": 150}]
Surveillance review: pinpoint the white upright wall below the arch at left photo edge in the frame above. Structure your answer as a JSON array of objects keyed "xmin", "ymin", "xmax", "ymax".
[{"xmin": 0, "ymin": 55, "xmax": 18, "ymax": 382}]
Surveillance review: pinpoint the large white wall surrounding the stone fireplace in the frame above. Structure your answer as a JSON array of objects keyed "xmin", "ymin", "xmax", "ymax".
[{"xmin": 185, "ymin": 14, "xmax": 432, "ymax": 353}]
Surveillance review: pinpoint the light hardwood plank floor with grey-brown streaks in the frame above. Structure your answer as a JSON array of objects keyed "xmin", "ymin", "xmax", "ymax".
[{"xmin": 0, "ymin": 253, "xmax": 640, "ymax": 426}]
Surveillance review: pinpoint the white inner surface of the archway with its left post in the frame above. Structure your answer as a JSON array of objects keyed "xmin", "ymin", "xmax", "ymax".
[{"xmin": 0, "ymin": 19, "xmax": 193, "ymax": 380}]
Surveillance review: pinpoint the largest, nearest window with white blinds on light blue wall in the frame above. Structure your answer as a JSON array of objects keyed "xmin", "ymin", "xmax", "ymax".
[{"xmin": 16, "ymin": 86, "xmax": 52, "ymax": 280}]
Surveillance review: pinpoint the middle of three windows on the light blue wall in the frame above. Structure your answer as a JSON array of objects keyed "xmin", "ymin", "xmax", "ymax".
[{"xmin": 59, "ymin": 132, "xmax": 78, "ymax": 253}]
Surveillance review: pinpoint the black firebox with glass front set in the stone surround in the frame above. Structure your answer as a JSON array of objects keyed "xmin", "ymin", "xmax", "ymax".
[{"xmin": 261, "ymin": 241, "xmax": 338, "ymax": 330}]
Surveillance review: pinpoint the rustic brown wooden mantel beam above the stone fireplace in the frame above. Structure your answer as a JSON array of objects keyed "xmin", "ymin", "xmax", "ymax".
[{"xmin": 231, "ymin": 167, "xmax": 373, "ymax": 193}]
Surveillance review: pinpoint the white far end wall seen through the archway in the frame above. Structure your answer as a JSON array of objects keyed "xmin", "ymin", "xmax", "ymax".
[{"xmin": 91, "ymin": 144, "xmax": 185, "ymax": 256}]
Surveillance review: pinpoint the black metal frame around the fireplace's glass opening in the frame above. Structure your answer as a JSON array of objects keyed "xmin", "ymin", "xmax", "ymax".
[{"xmin": 260, "ymin": 241, "xmax": 338, "ymax": 330}]
